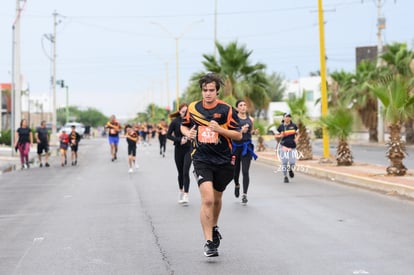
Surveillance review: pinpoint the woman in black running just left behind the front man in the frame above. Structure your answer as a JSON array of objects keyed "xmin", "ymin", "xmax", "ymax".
[{"xmin": 167, "ymin": 103, "xmax": 191, "ymax": 204}]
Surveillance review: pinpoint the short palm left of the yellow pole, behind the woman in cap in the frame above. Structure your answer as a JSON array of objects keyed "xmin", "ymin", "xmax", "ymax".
[{"xmin": 286, "ymin": 92, "xmax": 313, "ymax": 160}]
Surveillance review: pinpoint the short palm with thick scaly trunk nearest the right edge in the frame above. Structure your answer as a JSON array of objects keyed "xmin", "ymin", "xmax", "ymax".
[{"xmin": 370, "ymin": 72, "xmax": 414, "ymax": 176}]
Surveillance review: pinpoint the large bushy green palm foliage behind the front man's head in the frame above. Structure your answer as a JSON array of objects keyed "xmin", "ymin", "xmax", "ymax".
[{"xmin": 183, "ymin": 42, "xmax": 284, "ymax": 118}]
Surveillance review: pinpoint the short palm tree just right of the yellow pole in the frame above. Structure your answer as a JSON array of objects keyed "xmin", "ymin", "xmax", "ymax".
[{"xmin": 321, "ymin": 105, "xmax": 354, "ymax": 166}]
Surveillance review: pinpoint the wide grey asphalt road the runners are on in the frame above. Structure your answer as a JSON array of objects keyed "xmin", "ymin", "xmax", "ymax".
[{"xmin": 0, "ymin": 139, "xmax": 414, "ymax": 275}]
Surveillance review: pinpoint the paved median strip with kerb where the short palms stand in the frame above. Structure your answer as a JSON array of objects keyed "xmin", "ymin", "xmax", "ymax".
[{"xmin": 256, "ymin": 148, "xmax": 414, "ymax": 198}]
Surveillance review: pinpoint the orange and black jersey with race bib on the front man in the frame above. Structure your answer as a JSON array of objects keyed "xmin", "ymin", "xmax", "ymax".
[{"xmin": 182, "ymin": 100, "xmax": 240, "ymax": 165}]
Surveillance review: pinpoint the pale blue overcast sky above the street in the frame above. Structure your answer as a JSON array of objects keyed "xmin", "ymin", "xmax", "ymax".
[{"xmin": 0, "ymin": 0, "xmax": 414, "ymax": 118}]
